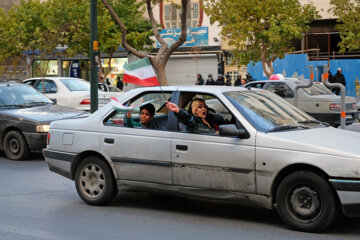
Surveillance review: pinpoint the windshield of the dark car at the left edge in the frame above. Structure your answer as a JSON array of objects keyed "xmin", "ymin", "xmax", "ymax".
[{"xmin": 0, "ymin": 85, "xmax": 53, "ymax": 108}]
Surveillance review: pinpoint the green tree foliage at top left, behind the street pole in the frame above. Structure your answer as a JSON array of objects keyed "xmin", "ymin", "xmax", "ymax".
[{"xmin": 0, "ymin": 0, "xmax": 152, "ymax": 65}]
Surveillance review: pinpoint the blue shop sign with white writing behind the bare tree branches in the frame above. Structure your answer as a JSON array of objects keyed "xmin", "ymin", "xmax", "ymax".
[{"xmin": 156, "ymin": 27, "xmax": 209, "ymax": 47}]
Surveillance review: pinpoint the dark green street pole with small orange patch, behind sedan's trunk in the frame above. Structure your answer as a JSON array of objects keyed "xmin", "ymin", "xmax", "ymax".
[{"xmin": 90, "ymin": 0, "xmax": 100, "ymax": 113}]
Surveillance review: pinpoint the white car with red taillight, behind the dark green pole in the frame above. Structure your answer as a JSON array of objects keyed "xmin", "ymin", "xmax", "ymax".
[{"xmin": 24, "ymin": 77, "xmax": 122, "ymax": 111}]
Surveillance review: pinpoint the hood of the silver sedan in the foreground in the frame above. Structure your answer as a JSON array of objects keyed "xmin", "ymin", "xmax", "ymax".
[{"xmin": 256, "ymin": 127, "xmax": 360, "ymax": 160}]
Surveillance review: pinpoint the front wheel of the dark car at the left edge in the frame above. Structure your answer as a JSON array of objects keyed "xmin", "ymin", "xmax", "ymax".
[{"xmin": 4, "ymin": 131, "xmax": 29, "ymax": 160}]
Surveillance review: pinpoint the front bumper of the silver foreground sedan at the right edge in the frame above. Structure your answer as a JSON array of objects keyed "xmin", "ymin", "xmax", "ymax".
[{"xmin": 330, "ymin": 179, "xmax": 360, "ymax": 217}]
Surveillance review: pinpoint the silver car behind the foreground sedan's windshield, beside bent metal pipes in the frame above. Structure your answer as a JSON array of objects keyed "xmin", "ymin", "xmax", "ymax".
[{"xmin": 245, "ymin": 78, "xmax": 359, "ymax": 126}]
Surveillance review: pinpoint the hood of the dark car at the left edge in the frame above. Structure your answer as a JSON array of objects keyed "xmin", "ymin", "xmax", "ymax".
[{"xmin": 1, "ymin": 105, "xmax": 88, "ymax": 122}]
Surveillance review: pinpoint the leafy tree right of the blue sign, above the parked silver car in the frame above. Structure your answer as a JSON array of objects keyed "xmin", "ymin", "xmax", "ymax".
[{"xmin": 204, "ymin": 0, "xmax": 319, "ymax": 77}]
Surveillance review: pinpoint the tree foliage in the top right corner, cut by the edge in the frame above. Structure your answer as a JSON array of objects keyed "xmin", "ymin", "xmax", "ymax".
[{"xmin": 329, "ymin": 0, "xmax": 360, "ymax": 52}]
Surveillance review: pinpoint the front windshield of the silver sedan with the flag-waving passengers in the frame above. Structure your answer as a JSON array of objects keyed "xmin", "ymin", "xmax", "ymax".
[{"xmin": 225, "ymin": 91, "xmax": 320, "ymax": 132}]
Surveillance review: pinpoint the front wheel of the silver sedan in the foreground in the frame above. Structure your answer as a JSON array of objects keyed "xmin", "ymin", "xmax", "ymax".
[{"xmin": 276, "ymin": 171, "xmax": 337, "ymax": 232}]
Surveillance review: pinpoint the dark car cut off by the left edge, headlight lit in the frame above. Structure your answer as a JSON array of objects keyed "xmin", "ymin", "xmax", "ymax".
[{"xmin": 0, "ymin": 82, "xmax": 87, "ymax": 160}]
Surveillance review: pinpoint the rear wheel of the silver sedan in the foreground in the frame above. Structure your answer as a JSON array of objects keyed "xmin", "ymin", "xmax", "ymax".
[{"xmin": 75, "ymin": 156, "xmax": 117, "ymax": 206}]
